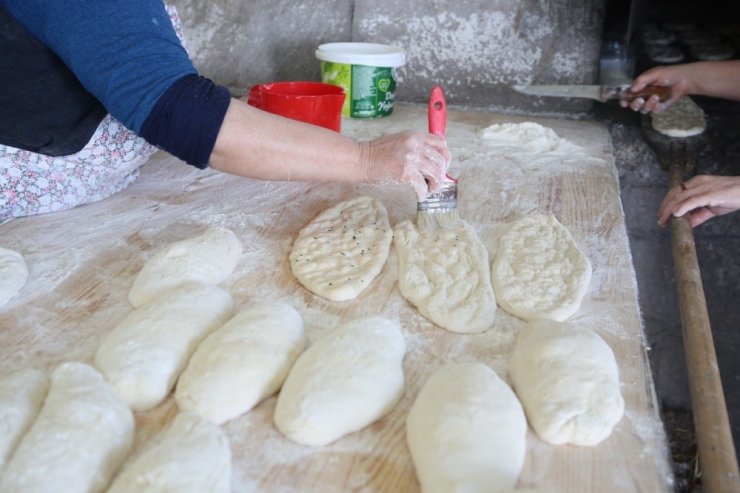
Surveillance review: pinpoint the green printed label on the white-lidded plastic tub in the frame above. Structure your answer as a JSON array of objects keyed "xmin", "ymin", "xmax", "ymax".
[{"xmin": 321, "ymin": 61, "xmax": 396, "ymax": 118}]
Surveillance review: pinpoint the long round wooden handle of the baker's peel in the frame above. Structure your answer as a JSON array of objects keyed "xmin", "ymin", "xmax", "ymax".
[{"xmin": 668, "ymin": 160, "xmax": 740, "ymax": 493}]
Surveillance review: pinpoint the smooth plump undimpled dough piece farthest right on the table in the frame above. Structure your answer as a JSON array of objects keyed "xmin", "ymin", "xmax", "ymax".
[{"xmin": 509, "ymin": 320, "xmax": 624, "ymax": 446}]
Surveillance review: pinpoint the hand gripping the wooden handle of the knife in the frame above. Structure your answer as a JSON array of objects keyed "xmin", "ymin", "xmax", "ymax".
[{"xmin": 620, "ymin": 65, "xmax": 693, "ymax": 113}]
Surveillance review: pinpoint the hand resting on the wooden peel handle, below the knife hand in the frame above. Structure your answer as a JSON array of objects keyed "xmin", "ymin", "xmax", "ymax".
[{"xmin": 658, "ymin": 175, "xmax": 740, "ymax": 228}]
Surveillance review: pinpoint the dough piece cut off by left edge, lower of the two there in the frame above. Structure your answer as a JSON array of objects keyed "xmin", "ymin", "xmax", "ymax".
[{"xmin": 0, "ymin": 368, "xmax": 49, "ymax": 471}]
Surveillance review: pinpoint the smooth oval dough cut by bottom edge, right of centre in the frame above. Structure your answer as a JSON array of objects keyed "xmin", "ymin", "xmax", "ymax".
[{"xmin": 406, "ymin": 363, "xmax": 527, "ymax": 493}]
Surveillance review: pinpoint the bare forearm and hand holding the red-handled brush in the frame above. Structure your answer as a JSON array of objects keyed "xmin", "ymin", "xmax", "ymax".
[{"xmin": 209, "ymin": 99, "xmax": 450, "ymax": 200}]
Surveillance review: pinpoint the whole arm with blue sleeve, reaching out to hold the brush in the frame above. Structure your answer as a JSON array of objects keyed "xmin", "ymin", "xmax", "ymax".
[{"xmin": 4, "ymin": 0, "xmax": 450, "ymax": 200}]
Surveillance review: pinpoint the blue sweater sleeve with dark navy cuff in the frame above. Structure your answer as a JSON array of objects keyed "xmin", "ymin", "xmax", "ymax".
[{"xmin": 0, "ymin": 0, "xmax": 230, "ymax": 167}]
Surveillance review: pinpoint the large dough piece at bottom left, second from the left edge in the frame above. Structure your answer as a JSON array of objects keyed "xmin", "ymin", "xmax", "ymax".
[{"xmin": 0, "ymin": 362, "xmax": 134, "ymax": 493}]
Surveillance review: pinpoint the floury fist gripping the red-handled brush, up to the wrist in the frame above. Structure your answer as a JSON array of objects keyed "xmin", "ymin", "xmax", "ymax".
[{"xmin": 360, "ymin": 131, "xmax": 450, "ymax": 202}]
